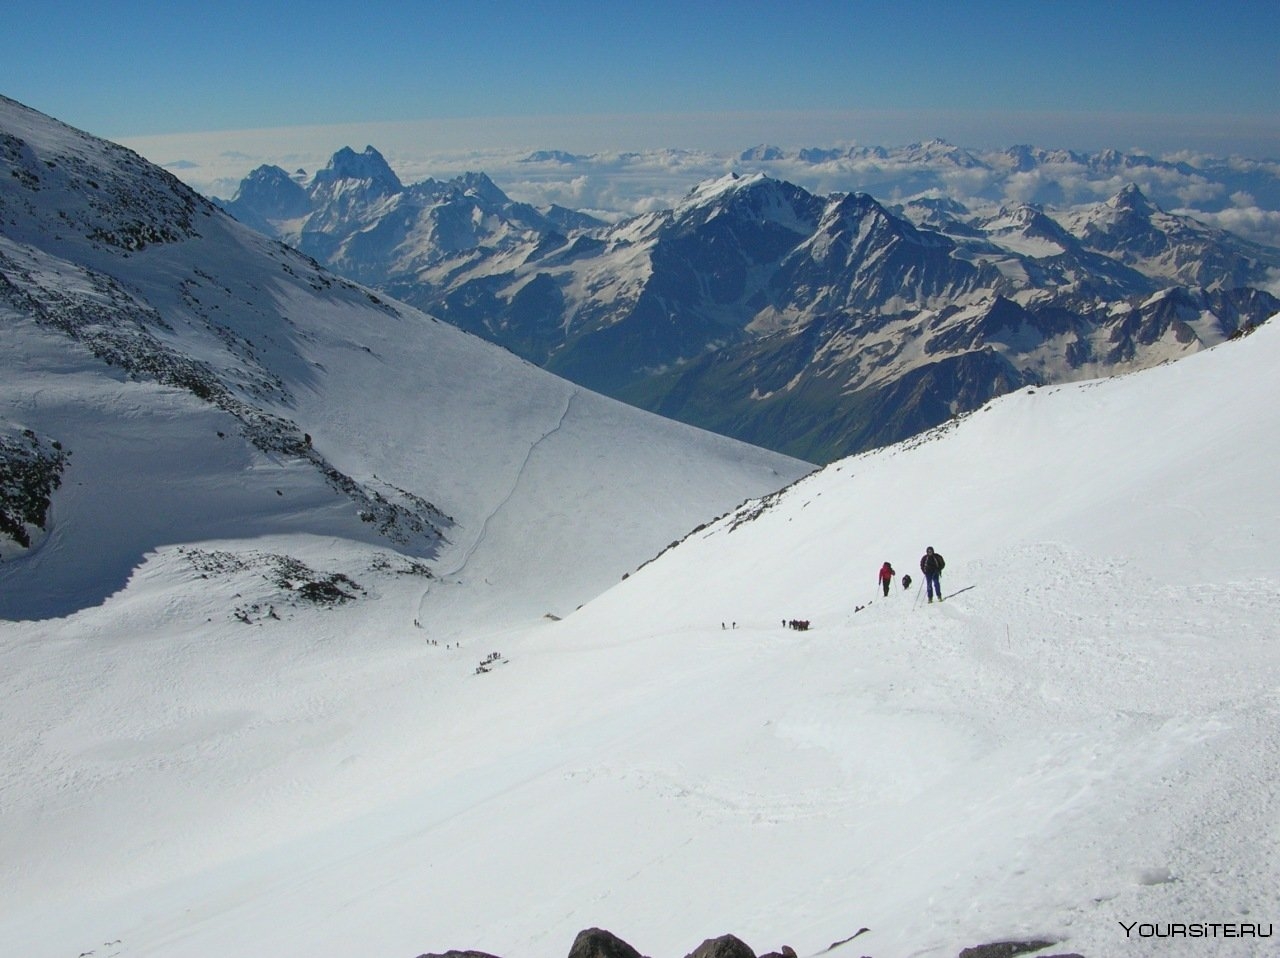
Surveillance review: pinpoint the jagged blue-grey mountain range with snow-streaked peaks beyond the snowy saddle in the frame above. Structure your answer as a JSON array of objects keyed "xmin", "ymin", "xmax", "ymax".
[{"xmin": 224, "ymin": 143, "xmax": 1280, "ymax": 462}]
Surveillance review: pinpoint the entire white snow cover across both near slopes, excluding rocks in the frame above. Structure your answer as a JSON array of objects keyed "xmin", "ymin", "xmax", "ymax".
[{"xmin": 0, "ymin": 95, "xmax": 1280, "ymax": 958}]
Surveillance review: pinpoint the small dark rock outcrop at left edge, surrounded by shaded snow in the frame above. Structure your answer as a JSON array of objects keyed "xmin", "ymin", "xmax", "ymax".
[{"xmin": 0, "ymin": 424, "xmax": 70, "ymax": 549}]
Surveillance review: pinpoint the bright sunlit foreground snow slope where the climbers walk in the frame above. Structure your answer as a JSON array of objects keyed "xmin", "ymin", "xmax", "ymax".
[{"xmin": 0, "ymin": 183, "xmax": 1280, "ymax": 958}]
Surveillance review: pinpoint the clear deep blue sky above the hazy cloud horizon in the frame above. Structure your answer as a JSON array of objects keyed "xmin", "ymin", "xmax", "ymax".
[{"xmin": 0, "ymin": 0, "xmax": 1280, "ymax": 156}]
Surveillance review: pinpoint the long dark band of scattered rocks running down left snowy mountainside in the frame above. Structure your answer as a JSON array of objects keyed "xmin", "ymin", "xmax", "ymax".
[{"xmin": 0, "ymin": 115, "xmax": 452, "ymax": 553}]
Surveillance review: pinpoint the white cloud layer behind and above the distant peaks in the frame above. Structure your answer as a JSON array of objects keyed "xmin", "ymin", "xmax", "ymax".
[{"xmin": 127, "ymin": 126, "xmax": 1280, "ymax": 246}]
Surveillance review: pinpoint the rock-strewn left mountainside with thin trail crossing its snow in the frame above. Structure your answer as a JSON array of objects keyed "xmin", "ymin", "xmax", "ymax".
[{"xmin": 0, "ymin": 93, "xmax": 808, "ymax": 633}]
